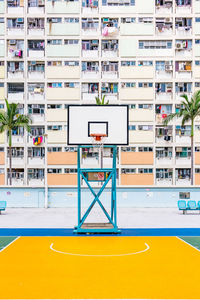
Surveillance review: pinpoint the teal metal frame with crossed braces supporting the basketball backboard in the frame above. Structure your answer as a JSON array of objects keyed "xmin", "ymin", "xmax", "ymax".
[{"xmin": 74, "ymin": 145, "xmax": 120, "ymax": 233}]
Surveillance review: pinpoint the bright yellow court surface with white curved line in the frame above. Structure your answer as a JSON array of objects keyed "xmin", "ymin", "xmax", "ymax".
[{"xmin": 0, "ymin": 236, "xmax": 200, "ymax": 299}]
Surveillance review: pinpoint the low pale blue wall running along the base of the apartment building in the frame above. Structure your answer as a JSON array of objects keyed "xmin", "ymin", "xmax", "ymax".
[{"xmin": 0, "ymin": 188, "xmax": 200, "ymax": 207}]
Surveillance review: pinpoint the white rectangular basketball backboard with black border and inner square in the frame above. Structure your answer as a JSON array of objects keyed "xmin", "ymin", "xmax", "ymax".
[{"xmin": 67, "ymin": 105, "xmax": 129, "ymax": 145}]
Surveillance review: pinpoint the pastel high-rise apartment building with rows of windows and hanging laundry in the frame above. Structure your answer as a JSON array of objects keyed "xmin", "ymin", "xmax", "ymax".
[{"xmin": 0, "ymin": 0, "xmax": 200, "ymax": 187}]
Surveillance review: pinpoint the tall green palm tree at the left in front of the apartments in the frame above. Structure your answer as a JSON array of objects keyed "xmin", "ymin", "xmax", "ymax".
[{"xmin": 0, "ymin": 99, "xmax": 31, "ymax": 185}]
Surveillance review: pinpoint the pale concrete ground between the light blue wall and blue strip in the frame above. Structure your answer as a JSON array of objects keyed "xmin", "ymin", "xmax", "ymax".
[{"xmin": 0, "ymin": 208, "xmax": 200, "ymax": 228}]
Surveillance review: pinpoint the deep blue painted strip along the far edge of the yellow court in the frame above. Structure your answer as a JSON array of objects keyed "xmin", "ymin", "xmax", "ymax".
[{"xmin": 0, "ymin": 228, "xmax": 200, "ymax": 237}]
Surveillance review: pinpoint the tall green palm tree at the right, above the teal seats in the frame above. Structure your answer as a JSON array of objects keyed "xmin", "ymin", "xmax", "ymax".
[{"xmin": 163, "ymin": 90, "xmax": 200, "ymax": 185}]
